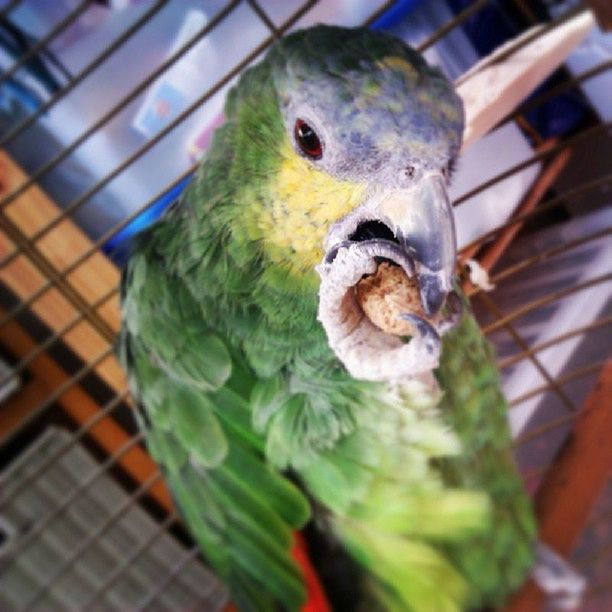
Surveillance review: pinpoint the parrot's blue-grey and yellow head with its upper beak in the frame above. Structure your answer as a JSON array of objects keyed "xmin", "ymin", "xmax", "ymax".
[{"xmin": 226, "ymin": 26, "xmax": 464, "ymax": 314}]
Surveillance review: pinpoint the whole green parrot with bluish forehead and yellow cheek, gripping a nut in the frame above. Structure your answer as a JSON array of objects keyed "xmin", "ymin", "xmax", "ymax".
[{"xmin": 119, "ymin": 26, "xmax": 536, "ymax": 612}]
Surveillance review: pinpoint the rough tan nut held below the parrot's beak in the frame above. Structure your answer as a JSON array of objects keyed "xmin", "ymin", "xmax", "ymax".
[{"xmin": 355, "ymin": 262, "xmax": 432, "ymax": 336}]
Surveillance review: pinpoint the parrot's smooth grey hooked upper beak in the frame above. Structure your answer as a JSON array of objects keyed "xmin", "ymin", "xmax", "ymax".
[{"xmin": 378, "ymin": 174, "xmax": 457, "ymax": 316}]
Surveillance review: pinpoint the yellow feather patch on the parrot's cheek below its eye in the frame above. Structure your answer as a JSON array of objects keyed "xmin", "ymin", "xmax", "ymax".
[{"xmin": 257, "ymin": 143, "xmax": 365, "ymax": 273}]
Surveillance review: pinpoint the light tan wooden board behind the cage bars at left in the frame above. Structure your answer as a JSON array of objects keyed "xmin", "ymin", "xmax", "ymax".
[{"xmin": 0, "ymin": 151, "xmax": 125, "ymax": 392}]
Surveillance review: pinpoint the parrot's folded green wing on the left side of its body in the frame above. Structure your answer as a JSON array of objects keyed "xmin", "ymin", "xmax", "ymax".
[{"xmin": 121, "ymin": 249, "xmax": 310, "ymax": 610}]
